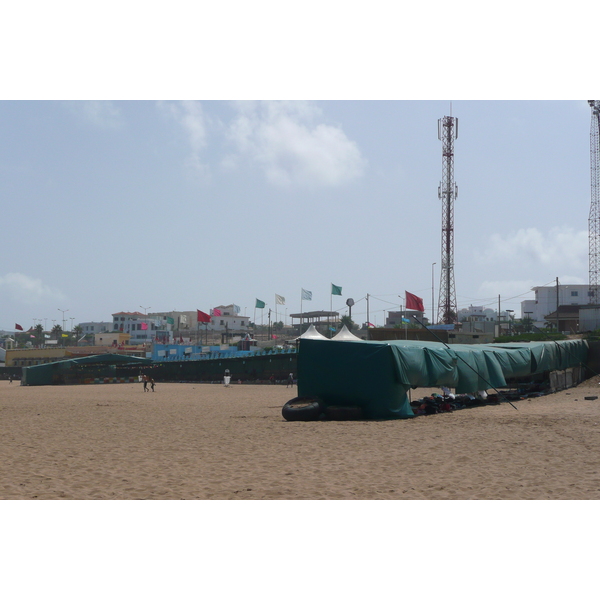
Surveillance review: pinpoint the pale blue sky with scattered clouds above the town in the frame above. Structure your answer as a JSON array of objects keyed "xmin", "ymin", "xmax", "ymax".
[{"xmin": 0, "ymin": 100, "xmax": 590, "ymax": 329}]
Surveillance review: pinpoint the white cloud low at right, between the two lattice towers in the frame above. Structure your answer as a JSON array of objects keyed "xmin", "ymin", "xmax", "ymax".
[{"xmin": 477, "ymin": 227, "xmax": 588, "ymax": 275}]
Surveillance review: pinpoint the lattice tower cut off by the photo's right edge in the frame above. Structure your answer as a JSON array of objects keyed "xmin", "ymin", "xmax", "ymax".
[{"xmin": 588, "ymin": 100, "xmax": 600, "ymax": 304}]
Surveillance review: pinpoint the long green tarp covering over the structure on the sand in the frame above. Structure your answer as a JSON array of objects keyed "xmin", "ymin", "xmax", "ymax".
[{"xmin": 298, "ymin": 339, "xmax": 588, "ymax": 419}]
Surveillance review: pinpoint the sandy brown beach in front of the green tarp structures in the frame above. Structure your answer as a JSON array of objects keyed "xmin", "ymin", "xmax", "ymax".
[{"xmin": 0, "ymin": 377, "xmax": 600, "ymax": 500}]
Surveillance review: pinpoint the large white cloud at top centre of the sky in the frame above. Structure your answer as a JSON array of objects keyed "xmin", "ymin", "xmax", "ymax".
[{"xmin": 225, "ymin": 102, "xmax": 366, "ymax": 186}]
